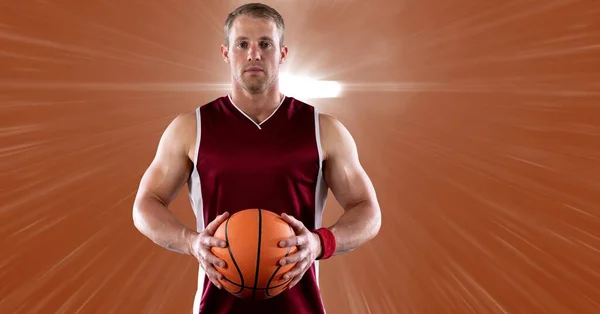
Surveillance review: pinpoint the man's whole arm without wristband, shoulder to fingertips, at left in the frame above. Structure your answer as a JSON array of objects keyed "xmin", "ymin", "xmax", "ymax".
[{"xmin": 133, "ymin": 112, "xmax": 229, "ymax": 289}]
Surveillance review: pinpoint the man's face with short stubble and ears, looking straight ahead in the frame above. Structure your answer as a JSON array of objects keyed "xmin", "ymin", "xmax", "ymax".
[{"xmin": 221, "ymin": 16, "xmax": 287, "ymax": 94}]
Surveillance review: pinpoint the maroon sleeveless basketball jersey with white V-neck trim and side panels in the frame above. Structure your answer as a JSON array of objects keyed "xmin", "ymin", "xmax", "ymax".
[{"xmin": 188, "ymin": 96, "xmax": 327, "ymax": 314}]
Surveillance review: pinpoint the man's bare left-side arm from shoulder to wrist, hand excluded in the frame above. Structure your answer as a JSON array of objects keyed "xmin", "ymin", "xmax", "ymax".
[{"xmin": 133, "ymin": 112, "xmax": 196, "ymax": 254}]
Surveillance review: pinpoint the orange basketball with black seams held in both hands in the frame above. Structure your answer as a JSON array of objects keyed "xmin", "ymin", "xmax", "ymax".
[{"xmin": 211, "ymin": 209, "xmax": 297, "ymax": 300}]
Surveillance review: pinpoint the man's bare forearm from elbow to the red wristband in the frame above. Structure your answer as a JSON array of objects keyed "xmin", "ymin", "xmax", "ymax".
[{"xmin": 329, "ymin": 201, "xmax": 381, "ymax": 255}]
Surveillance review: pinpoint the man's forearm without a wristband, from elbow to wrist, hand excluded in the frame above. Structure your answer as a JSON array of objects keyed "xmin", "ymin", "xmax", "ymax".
[{"xmin": 133, "ymin": 197, "xmax": 197, "ymax": 255}]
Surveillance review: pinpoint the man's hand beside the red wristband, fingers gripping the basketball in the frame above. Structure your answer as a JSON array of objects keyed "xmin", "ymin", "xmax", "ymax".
[{"xmin": 279, "ymin": 214, "xmax": 321, "ymax": 289}]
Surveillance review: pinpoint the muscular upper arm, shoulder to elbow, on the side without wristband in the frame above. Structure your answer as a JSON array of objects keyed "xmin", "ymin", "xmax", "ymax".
[{"xmin": 137, "ymin": 114, "xmax": 195, "ymax": 205}]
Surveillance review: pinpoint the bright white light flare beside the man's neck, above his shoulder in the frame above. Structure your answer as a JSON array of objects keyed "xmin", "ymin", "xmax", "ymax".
[{"xmin": 279, "ymin": 73, "xmax": 342, "ymax": 99}]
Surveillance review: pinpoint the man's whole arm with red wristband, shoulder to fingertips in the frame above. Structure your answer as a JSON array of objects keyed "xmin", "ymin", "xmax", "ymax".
[{"xmin": 279, "ymin": 114, "xmax": 381, "ymax": 289}]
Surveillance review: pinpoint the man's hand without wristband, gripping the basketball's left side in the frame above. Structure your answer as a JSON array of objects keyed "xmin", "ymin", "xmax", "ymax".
[{"xmin": 190, "ymin": 212, "xmax": 229, "ymax": 289}]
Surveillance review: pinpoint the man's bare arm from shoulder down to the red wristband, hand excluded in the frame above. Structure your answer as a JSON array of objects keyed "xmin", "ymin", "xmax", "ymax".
[{"xmin": 319, "ymin": 114, "xmax": 381, "ymax": 255}]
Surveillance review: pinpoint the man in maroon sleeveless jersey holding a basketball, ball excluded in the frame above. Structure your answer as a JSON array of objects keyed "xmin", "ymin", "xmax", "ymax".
[{"xmin": 133, "ymin": 3, "xmax": 381, "ymax": 314}]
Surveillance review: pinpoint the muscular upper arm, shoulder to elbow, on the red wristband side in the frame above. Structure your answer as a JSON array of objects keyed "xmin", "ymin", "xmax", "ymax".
[{"xmin": 320, "ymin": 115, "xmax": 375, "ymax": 209}]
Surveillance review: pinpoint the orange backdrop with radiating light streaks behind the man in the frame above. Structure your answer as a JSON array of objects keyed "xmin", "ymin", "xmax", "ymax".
[{"xmin": 0, "ymin": 0, "xmax": 600, "ymax": 314}]
